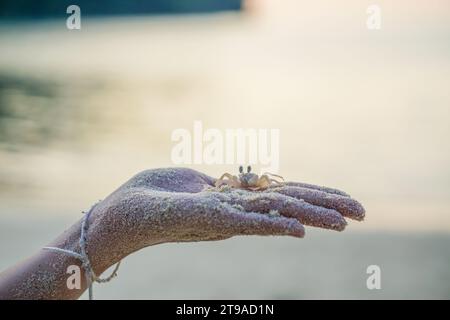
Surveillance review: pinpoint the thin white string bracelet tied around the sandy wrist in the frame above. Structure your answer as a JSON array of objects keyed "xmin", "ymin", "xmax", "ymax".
[{"xmin": 43, "ymin": 203, "xmax": 121, "ymax": 300}]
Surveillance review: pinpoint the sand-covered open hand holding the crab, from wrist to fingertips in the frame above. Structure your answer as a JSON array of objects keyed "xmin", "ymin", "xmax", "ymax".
[{"xmin": 84, "ymin": 168, "xmax": 364, "ymax": 267}]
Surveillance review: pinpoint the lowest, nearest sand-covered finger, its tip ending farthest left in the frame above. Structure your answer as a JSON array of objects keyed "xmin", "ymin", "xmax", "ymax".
[{"xmin": 222, "ymin": 203, "xmax": 305, "ymax": 238}]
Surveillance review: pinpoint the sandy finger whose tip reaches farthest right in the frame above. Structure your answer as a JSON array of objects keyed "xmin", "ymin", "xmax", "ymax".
[{"xmin": 272, "ymin": 186, "xmax": 365, "ymax": 221}]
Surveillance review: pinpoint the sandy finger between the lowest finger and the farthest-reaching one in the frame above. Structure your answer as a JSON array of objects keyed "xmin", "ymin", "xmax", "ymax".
[{"xmin": 223, "ymin": 193, "xmax": 347, "ymax": 231}]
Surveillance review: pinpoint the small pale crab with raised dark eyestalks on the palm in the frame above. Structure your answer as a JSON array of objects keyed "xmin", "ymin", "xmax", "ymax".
[{"xmin": 215, "ymin": 166, "xmax": 284, "ymax": 191}]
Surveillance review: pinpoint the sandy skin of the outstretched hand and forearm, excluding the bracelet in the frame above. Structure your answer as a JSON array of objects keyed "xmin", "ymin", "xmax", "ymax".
[{"xmin": 0, "ymin": 168, "xmax": 364, "ymax": 299}]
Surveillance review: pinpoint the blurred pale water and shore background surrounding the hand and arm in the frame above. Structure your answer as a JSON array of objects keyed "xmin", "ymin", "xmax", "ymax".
[{"xmin": 0, "ymin": 0, "xmax": 450, "ymax": 299}]
